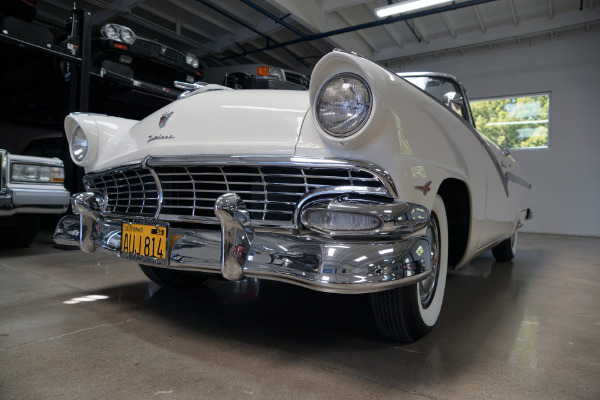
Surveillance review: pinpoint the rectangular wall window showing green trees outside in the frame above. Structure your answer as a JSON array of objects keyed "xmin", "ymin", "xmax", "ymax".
[{"xmin": 471, "ymin": 94, "xmax": 550, "ymax": 149}]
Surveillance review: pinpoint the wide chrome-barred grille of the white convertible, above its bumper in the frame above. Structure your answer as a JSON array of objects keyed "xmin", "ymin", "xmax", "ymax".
[{"xmin": 86, "ymin": 165, "xmax": 385, "ymax": 225}]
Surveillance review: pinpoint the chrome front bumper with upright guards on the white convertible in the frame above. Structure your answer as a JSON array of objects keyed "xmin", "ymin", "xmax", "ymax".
[{"xmin": 54, "ymin": 192, "xmax": 431, "ymax": 293}]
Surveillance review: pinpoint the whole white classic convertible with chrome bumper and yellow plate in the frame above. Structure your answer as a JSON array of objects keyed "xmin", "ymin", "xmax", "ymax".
[{"xmin": 55, "ymin": 51, "xmax": 531, "ymax": 341}]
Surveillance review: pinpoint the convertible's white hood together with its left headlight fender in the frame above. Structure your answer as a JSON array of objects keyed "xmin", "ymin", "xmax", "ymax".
[{"xmin": 75, "ymin": 90, "xmax": 309, "ymax": 172}]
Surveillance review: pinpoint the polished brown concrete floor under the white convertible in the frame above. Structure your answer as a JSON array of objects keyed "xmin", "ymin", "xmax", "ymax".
[{"xmin": 0, "ymin": 228, "xmax": 600, "ymax": 400}]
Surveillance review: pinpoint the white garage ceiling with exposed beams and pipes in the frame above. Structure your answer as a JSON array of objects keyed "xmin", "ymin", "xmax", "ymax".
[{"xmin": 37, "ymin": 0, "xmax": 600, "ymax": 72}]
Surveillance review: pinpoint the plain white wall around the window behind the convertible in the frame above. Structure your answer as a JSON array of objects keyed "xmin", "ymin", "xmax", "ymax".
[{"xmin": 390, "ymin": 30, "xmax": 600, "ymax": 236}]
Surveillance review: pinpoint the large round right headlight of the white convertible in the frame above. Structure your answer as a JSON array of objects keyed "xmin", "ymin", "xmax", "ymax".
[{"xmin": 316, "ymin": 73, "xmax": 373, "ymax": 138}]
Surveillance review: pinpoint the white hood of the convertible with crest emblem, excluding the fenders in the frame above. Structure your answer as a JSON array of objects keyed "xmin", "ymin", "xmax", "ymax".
[{"xmin": 130, "ymin": 90, "xmax": 309, "ymax": 155}]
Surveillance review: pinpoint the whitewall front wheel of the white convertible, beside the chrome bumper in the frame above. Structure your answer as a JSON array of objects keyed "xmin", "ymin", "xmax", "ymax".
[{"xmin": 370, "ymin": 195, "xmax": 448, "ymax": 342}]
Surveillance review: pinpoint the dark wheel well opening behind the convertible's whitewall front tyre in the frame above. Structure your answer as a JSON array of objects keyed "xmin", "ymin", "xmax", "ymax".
[{"xmin": 438, "ymin": 179, "xmax": 471, "ymax": 267}]
